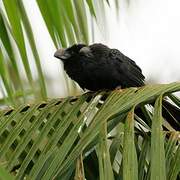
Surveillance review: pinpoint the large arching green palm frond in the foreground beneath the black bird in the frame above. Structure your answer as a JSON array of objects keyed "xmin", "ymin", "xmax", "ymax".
[{"xmin": 0, "ymin": 83, "xmax": 180, "ymax": 179}]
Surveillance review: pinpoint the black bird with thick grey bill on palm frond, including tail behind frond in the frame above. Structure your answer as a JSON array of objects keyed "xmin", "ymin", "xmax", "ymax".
[{"xmin": 54, "ymin": 44, "xmax": 180, "ymax": 130}]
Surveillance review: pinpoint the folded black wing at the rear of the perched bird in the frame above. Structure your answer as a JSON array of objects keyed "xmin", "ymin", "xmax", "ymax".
[{"xmin": 109, "ymin": 49, "xmax": 145, "ymax": 87}]
